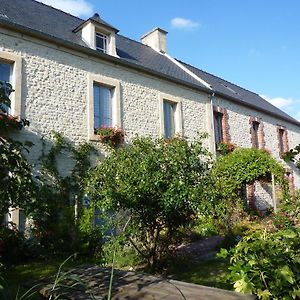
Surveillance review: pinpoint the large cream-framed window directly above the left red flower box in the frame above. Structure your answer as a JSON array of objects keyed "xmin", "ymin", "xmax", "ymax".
[{"xmin": 88, "ymin": 74, "xmax": 121, "ymax": 140}]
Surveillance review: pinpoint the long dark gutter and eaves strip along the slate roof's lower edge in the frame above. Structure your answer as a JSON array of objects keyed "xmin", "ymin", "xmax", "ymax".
[{"xmin": 0, "ymin": 18, "xmax": 300, "ymax": 126}]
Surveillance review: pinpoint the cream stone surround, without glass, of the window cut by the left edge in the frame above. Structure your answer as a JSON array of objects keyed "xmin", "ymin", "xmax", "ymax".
[{"xmin": 0, "ymin": 51, "xmax": 22, "ymax": 118}]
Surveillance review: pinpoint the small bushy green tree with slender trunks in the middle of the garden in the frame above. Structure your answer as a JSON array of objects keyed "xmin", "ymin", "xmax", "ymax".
[{"xmin": 87, "ymin": 138, "xmax": 210, "ymax": 267}]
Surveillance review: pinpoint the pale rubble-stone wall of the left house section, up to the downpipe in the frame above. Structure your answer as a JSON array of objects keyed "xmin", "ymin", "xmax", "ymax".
[{"xmin": 0, "ymin": 30, "xmax": 209, "ymax": 173}]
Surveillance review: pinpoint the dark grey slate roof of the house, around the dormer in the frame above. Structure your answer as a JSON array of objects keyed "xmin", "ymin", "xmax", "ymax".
[{"xmin": 0, "ymin": 0, "xmax": 300, "ymax": 125}]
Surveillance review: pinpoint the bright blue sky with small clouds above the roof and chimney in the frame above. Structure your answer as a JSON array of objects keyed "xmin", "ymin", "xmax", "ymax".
[{"xmin": 40, "ymin": 0, "xmax": 300, "ymax": 120}]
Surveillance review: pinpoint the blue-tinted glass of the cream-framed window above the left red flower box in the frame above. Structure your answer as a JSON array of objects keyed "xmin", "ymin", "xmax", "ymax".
[{"xmin": 94, "ymin": 85, "xmax": 112, "ymax": 128}]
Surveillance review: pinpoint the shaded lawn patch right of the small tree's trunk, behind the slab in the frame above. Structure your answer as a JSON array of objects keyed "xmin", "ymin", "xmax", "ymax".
[{"xmin": 168, "ymin": 258, "xmax": 233, "ymax": 290}]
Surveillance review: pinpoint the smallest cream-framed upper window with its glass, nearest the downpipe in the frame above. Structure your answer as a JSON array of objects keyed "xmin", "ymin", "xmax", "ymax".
[{"xmin": 159, "ymin": 94, "xmax": 182, "ymax": 139}]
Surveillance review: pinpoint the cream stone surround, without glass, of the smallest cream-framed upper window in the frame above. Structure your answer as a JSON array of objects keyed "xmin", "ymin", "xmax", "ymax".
[{"xmin": 159, "ymin": 93, "xmax": 183, "ymax": 138}]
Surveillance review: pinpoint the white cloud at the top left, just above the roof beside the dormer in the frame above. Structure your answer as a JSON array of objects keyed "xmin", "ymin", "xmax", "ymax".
[{"xmin": 39, "ymin": 0, "xmax": 93, "ymax": 17}]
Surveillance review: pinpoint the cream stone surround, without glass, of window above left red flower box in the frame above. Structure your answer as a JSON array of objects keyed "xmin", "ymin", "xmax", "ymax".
[{"xmin": 87, "ymin": 74, "xmax": 122, "ymax": 141}]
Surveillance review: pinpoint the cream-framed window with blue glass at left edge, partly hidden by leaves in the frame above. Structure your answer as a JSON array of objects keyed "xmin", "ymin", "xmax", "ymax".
[{"xmin": 0, "ymin": 51, "xmax": 22, "ymax": 117}]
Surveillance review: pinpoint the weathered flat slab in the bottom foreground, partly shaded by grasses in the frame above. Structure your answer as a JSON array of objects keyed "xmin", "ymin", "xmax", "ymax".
[{"xmin": 41, "ymin": 265, "xmax": 255, "ymax": 300}]
